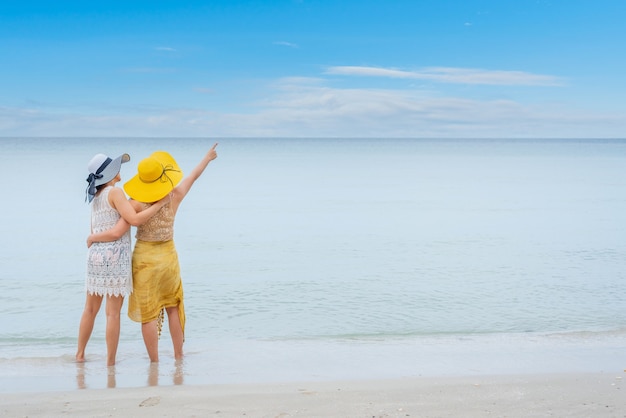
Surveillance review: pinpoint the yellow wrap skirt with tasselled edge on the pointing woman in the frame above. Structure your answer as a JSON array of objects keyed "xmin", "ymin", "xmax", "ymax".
[{"xmin": 128, "ymin": 240, "xmax": 185, "ymax": 335}]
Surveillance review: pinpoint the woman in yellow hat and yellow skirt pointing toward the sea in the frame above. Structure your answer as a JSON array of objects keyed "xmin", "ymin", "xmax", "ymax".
[{"xmin": 90, "ymin": 143, "xmax": 217, "ymax": 362}]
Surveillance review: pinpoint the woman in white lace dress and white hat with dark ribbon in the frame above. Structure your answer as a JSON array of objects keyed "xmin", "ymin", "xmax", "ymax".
[{"xmin": 76, "ymin": 154, "xmax": 168, "ymax": 366}]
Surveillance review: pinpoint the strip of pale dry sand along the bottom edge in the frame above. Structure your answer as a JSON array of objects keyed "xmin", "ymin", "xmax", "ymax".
[{"xmin": 0, "ymin": 371, "xmax": 626, "ymax": 417}]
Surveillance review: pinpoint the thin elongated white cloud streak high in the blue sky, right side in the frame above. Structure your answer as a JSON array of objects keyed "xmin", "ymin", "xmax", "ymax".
[{"xmin": 326, "ymin": 66, "xmax": 563, "ymax": 86}]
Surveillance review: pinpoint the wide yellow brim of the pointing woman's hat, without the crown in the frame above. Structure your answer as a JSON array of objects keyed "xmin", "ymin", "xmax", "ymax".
[{"xmin": 124, "ymin": 151, "xmax": 183, "ymax": 203}]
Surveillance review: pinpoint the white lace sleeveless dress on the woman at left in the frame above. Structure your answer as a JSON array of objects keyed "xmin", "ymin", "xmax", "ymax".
[{"xmin": 85, "ymin": 186, "xmax": 133, "ymax": 296}]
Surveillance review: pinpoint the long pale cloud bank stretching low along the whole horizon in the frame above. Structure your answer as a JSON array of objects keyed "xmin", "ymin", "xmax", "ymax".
[{"xmin": 0, "ymin": 77, "xmax": 626, "ymax": 138}]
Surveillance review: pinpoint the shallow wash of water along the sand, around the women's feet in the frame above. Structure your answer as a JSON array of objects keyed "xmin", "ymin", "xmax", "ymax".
[{"xmin": 0, "ymin": 332, "xmax": 626, "ymax": 396}]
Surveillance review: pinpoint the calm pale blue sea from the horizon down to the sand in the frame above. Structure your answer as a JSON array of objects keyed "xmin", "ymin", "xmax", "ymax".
[{"xmin": 0, "ymin": 138, "xmax": 626, "ymax": 391}]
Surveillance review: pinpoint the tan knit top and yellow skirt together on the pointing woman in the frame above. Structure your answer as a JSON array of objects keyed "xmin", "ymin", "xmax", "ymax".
[{"xmin": 128, "ymin": 204, "xmax": 185, "ymax": 335}]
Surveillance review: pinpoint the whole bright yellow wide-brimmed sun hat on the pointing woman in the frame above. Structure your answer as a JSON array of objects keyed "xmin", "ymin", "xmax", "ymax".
[{"xmin": 124, "ymin": 151, "xmax": 183, "ymax": 203}]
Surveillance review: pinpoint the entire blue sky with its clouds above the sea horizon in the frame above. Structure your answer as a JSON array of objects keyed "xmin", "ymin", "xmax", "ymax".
[{"xmin": 0, "ymin": 0, "xmax": 626, "ymax": 138}]
